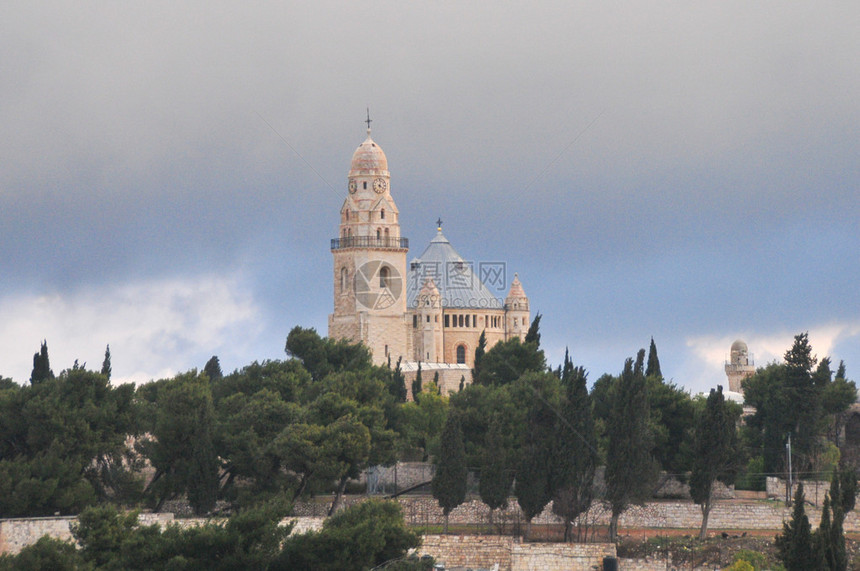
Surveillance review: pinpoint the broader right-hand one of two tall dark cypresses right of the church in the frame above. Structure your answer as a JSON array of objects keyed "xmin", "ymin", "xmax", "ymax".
[{"xmin": 606, "ymin": 349, "xmax": 657, "ymax": 541}]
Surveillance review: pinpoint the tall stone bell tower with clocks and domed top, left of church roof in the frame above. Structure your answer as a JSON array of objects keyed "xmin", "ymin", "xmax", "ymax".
[{"xmin": 328, "ymin": 115, "xmax": 411, "ymax": 364}]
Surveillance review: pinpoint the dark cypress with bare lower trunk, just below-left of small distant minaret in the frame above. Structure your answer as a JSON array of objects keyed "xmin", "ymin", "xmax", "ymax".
[{"xmin": 690, "ymin": 386, "xmax": 738, "ymax": 540}]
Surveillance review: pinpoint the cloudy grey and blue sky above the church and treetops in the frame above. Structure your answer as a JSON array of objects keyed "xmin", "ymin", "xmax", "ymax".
[{"xmin": 0, "ymin": 0, "xmax": 860, "ymax": 393}]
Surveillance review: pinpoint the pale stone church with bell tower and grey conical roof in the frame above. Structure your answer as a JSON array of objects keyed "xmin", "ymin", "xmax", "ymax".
[{"xmin": 328, "ymin": 124, "xmax": 530, "ymax": 394}]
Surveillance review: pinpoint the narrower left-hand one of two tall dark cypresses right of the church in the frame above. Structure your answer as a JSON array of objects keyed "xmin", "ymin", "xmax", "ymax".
[{"xmin": 550, "ymin": 358, "xmax": 598, "ymax": 541}]
